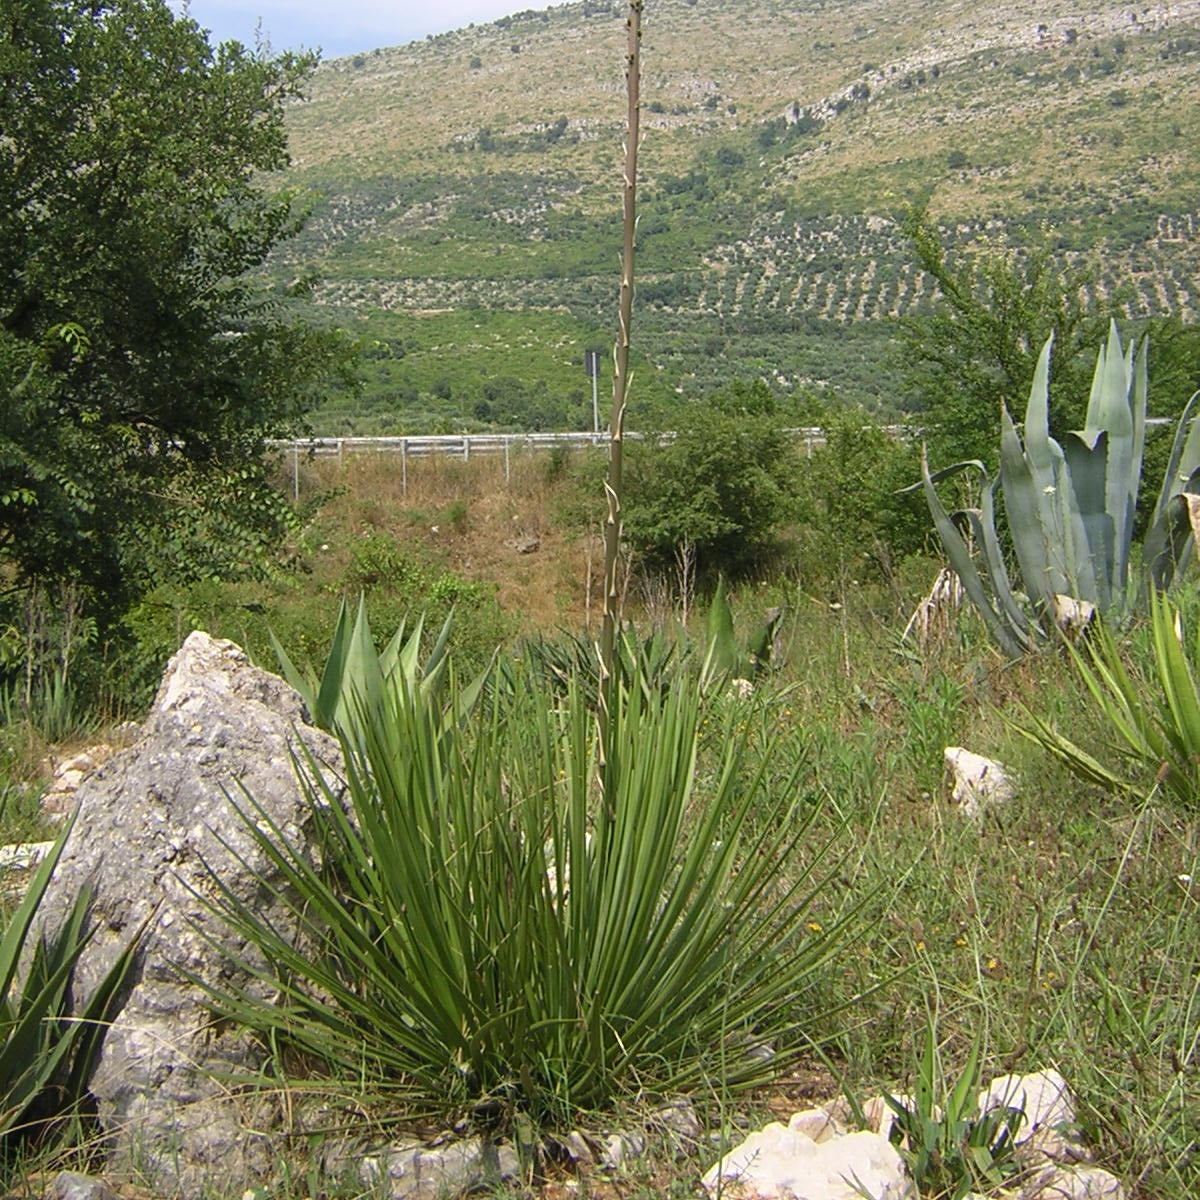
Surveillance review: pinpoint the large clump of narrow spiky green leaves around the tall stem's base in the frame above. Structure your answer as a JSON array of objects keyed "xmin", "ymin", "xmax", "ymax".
[{"xmin": 196, "ymin": 652, "xmax": 851, "ymax": 1121}]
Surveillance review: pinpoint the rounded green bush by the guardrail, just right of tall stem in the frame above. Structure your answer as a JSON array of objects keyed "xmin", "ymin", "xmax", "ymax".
[{"xmin": 624, "ymin": 380, "xmax": 798, "ymax": 578}]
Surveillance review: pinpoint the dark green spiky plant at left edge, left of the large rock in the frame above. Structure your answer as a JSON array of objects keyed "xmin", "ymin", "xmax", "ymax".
[{"xmin": 0, "ymin": 815, "xmax": 138, "ymax": 1165}]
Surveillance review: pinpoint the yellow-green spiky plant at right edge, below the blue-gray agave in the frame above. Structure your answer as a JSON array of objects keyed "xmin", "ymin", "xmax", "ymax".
[{"xmin": 1018, "ymin": 593, "xmax": 1200, "ymax": 809}]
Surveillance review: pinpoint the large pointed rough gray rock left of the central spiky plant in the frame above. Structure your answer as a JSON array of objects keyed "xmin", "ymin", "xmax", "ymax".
[{"xmin": 36, "ymin": 632, "xmax": 341, "ymax": 1198}]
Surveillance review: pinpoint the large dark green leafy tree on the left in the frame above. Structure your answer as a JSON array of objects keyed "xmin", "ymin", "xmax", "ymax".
[{"xmin": 0, "ymin": 0, "xmax": 349, "ymax": 607}]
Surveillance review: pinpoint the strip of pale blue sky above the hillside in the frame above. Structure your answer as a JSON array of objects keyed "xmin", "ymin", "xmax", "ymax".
[{"xmin": 172, "ymin": 0, "xmax": 576, "ymax": 59}]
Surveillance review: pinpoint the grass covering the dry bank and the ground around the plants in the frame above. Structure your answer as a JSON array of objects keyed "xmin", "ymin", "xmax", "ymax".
[{"xmin": 2, "ymin": 457, "xmax": 1200, "ymax": 1200}]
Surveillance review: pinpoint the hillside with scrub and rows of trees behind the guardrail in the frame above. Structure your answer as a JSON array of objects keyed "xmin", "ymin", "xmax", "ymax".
[{"xmin": 272, "ymin": 0, "xmax": 1200, "ymax": 432}]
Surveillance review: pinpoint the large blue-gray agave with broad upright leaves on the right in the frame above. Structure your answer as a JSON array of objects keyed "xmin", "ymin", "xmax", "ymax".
[{"xmin": 916, "ymin": 322, "xmax": 1200, "ymax": 655}]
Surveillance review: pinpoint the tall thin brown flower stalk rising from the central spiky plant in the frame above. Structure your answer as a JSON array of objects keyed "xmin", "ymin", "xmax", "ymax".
[{"xmin": 598, "ymin": 0, "xmax": 643, "ymax": 746}]
